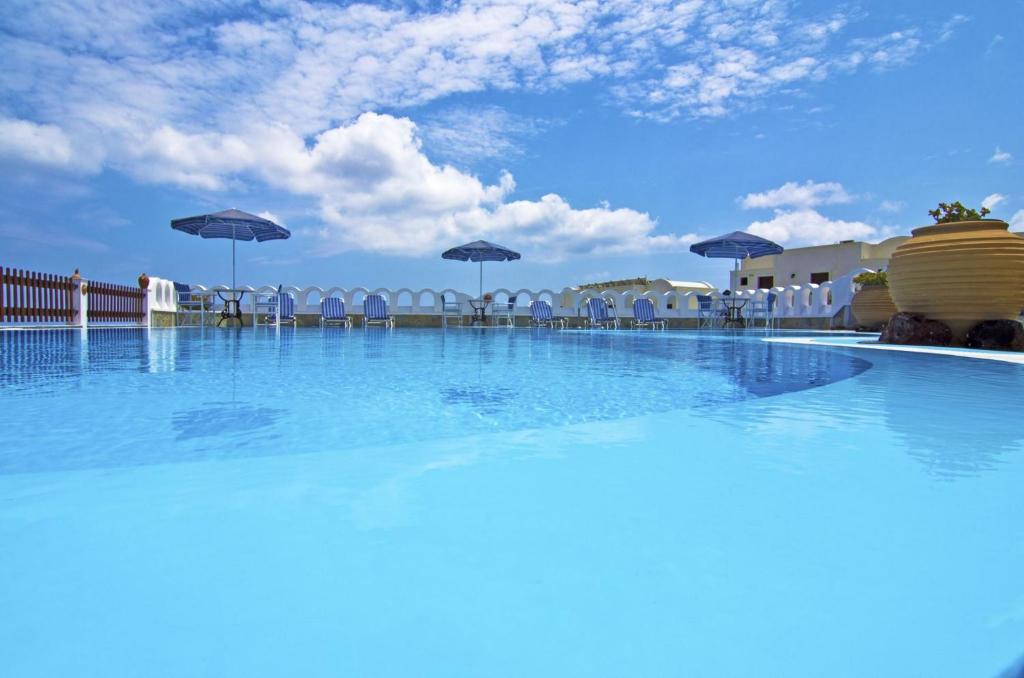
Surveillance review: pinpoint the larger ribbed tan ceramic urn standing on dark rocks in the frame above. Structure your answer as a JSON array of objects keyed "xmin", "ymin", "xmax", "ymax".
[{"xmin": 888, "ymin": 219, "xmax": 1024, "ymax": 343}]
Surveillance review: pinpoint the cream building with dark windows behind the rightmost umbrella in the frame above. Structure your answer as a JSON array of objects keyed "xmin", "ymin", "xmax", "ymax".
[{"xmin": 729, "ymin": 236, "xmax": 909, "ymax": 290}]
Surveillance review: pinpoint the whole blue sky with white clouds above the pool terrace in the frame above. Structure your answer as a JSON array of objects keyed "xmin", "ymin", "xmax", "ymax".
[{"xmin": 0, "ymin": 0, "xmax": 1024, "ymax": 291}]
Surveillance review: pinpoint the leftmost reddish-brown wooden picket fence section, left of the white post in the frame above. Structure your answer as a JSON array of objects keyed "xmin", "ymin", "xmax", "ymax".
[{"xmin": 0, "ymin": 266, "xmax": 75, "ymax": 323}]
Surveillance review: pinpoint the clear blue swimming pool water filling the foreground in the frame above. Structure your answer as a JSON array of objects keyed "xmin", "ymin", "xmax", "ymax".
[{"xmin": 0, "ymin": 329, "xmax": 1024, "ymax": 677}]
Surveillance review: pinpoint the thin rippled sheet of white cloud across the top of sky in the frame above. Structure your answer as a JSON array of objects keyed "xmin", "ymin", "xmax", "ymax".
[{"xmin": 0, "ymin": 0, "xmax": 920, "ymax": 135}]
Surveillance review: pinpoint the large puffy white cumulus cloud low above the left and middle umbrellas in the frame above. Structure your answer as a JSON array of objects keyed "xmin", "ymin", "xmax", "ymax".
[{"xmin": 121, "ymin": 113, "xmax": 696, "ymax": 261}]
